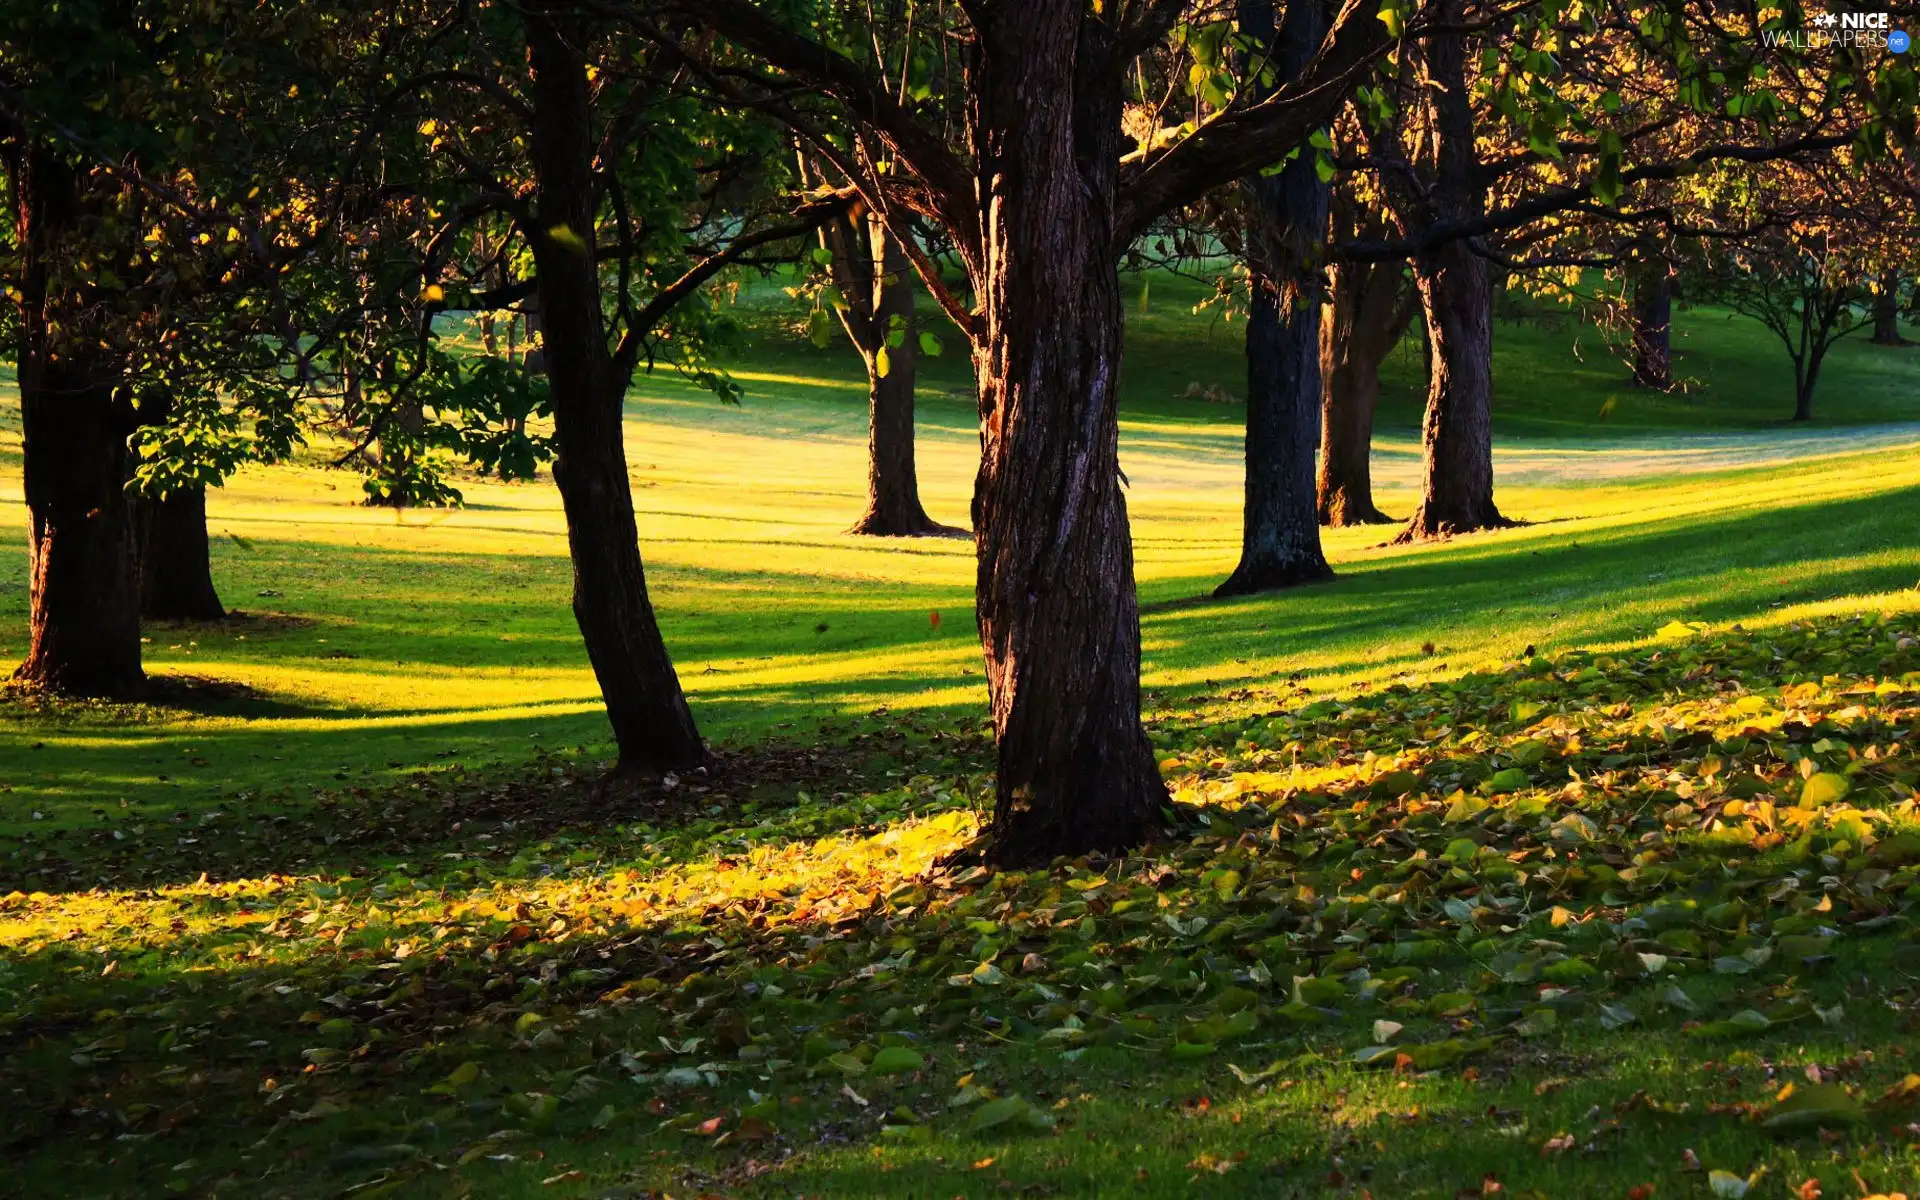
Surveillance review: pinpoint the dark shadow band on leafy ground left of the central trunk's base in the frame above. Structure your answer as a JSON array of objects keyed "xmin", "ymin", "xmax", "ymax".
[{"xmin": 0, "ymin": 708, "xmax": 991, "ymax": 895}]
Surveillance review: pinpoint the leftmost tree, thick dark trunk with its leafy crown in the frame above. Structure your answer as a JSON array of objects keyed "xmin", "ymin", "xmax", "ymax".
[{"xmin": 0, "ymin": 0, "xmax": 362, "ymax": 683}]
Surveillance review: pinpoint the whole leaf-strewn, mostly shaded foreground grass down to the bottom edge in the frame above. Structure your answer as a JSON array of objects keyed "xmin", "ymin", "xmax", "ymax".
[{"xmin": 0, "ymin": 607, "xmax": 1920, "ymax": 1196}]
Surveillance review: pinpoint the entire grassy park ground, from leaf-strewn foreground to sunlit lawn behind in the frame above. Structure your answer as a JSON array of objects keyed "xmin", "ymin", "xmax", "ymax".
[{"xmin": 0, "ymin": 278, "xmax": 1920, "ymax": 1200}]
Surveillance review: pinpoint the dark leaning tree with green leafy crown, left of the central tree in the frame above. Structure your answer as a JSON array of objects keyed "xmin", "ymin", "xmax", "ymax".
[{"xmin": 359, "ymin": 0, "xmax": 845, "ymax": 774}]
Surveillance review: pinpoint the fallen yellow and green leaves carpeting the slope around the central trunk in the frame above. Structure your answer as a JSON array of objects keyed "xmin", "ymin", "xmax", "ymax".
[{"xmin": 0, "ymin": 618, "xmax": 1920, "ymax": 1188}]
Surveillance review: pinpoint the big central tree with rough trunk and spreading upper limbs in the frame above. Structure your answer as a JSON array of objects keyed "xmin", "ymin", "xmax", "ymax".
[{"xmin": 660, "ymin": 0, "xmax": 1390, "ymax": 862}]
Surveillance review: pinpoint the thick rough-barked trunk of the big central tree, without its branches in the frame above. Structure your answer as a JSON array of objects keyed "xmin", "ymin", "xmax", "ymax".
[{"xmin": 968, "ymin": 0, "xmax": 1167, "ymax": 862}]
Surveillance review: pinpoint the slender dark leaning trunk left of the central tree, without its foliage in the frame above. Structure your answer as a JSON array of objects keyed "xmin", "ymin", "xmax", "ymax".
[{"xmin": 524, "ymin": 10, "xmax": 707, "ymax": 774}]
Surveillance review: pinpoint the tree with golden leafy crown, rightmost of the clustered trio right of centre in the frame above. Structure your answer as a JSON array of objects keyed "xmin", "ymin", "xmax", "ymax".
[{"xmin": 1336, "ymin": 0, "xmax": 1884, "ymax": 541}]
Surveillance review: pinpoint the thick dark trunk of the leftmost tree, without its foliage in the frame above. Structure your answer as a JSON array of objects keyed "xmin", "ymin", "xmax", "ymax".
[{"xmin": 12, "ymin": 150, "xmax": 146, "ymax": 695}]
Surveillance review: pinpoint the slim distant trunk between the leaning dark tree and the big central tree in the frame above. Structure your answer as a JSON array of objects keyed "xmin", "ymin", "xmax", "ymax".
[{"xmin": 843, "ymin": 217, "xmax": 962, "ymax": 538}]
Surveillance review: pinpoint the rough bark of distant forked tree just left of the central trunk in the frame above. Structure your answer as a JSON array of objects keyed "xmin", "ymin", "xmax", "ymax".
[{"xmin": 820, "ymin": 213, "xmax": 966, "ymax": 538}]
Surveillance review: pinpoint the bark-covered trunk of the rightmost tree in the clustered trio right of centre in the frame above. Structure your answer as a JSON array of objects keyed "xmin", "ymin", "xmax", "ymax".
[{"xmin": 1394, "ymin": 0, "xmax": 1511, "ymax": 541}]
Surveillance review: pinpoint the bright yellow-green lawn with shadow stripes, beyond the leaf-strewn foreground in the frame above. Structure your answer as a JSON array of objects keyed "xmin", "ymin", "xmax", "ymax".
[{"xmin": 0, "ymin": 288, "xmax": 1920, "ymax": 828}]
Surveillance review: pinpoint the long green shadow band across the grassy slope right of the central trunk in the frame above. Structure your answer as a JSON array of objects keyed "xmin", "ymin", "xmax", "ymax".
[{"xmin": 1142, "ymin": 488, "xmax": 1920, "ymax": 697}]
